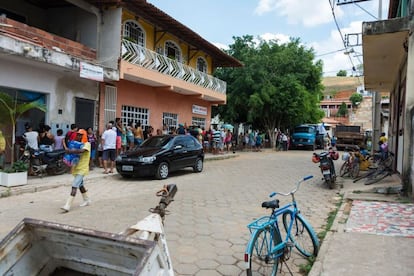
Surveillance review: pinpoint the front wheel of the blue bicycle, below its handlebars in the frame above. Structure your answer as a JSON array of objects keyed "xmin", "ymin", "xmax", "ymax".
[{"xmin": 283, "ymin": 212, "xmax": 319, "ymax": 257}]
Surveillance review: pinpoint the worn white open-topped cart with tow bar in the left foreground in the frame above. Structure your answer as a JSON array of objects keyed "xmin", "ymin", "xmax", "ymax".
[{"xmin": 0, "ymin": 184, "xmax": 177, "ymax": 276}]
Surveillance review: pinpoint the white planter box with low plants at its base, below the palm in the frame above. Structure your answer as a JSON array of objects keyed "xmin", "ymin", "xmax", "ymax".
[{"xmin": 0, "ymin": 160, "xmax": 29, "ymax": 187}]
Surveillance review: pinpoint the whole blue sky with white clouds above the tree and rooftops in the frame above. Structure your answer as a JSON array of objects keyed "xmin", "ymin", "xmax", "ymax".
[{"xmin": 147, "ymin": 0, "xmax": 389, "ymax": 76}]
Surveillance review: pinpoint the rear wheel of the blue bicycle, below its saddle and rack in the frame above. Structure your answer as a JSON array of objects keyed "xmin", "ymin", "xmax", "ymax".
[{"xmin": 246, "ymin": 227, "xmax": 283, "ymax": 276}]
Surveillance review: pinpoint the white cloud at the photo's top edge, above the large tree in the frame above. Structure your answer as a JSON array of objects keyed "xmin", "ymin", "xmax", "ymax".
[{"xmin": 254, "ymin": 0, "xmax": 343, "ymax": 27}]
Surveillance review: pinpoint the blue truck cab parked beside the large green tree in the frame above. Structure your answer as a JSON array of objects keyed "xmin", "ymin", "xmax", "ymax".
[{"xmin": 290, "ymin": 124, "xmax": 318, "ymax": 150}]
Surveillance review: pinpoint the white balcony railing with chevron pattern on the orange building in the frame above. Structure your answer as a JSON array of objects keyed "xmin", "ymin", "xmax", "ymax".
[{"xmin": 122, "ymin": 39, "xmax": 226, "ymax": 94}]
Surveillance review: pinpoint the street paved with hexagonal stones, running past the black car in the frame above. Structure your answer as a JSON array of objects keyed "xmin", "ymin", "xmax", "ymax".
[{"xmin": 0, "ymin": 150, "xmax": 340, "ymax": 276}]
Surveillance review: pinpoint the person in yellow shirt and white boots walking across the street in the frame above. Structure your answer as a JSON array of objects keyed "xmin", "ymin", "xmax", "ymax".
[{"xmin": 61, "ymin": 129, "xmax": 92, "ymax": 213}]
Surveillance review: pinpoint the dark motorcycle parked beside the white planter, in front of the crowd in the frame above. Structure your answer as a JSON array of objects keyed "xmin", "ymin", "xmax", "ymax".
[{"xmin": 20, "ymin": 146, "xmax": 69, "ymax": 176}]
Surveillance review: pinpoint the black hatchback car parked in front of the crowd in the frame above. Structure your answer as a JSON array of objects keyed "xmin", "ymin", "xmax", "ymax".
[{"xmin": 116, "ymin": 135, "xmax": 204, "ymax": 179}]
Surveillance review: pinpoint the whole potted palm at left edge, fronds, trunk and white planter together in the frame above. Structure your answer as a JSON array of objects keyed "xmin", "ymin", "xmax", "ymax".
[{"xmin": 0, "ymin": 91, "xmax": 46, "ymax": 186}]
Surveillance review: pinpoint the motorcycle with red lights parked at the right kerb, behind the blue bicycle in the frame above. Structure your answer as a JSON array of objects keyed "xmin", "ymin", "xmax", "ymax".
[{"xmin": 312, "ymin": 150, "xmax": 339, "ymax": 189}]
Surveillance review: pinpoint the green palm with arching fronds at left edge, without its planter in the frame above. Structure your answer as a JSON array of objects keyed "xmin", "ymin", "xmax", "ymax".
[{"xmin": 0, "ymin": 92, "xmax": 46, "ymax": 163}]
